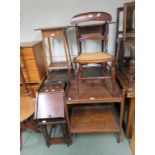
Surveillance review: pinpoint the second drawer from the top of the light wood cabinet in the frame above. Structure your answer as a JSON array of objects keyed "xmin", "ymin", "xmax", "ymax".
[{"xmin": 20, "ymin": 59, "xmax": 38, "ymax": 72}]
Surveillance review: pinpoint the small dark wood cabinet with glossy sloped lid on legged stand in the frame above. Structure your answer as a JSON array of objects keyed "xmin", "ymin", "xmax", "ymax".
[{"xmin": 34, "ymin": 80, "xmax": 71, "ymax": 146}]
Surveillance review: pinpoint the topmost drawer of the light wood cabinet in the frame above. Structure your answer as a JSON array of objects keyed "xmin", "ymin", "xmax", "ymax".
[{"xmin": 20, "ymin": 47, "xmax": 35, "ymax": 60}]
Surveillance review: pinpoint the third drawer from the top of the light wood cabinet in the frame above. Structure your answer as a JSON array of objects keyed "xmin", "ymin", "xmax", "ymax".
[{"xmin": 23, "ymin": 71, "xmax": 41, "ymax": 83}]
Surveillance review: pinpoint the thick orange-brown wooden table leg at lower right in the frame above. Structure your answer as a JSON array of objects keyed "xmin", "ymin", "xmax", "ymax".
[{"xmin": 125, "ymin": 98, "xmax": 135, "ymax": 138}]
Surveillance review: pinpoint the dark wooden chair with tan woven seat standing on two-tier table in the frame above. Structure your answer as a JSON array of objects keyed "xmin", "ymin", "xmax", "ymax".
[{"xmin": 71, "ymin": 12, "xmax": 115, "ymax": 95}]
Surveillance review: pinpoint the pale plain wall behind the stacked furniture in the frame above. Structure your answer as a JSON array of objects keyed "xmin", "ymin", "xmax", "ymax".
[{"xmin": 20, "ymin": 0, "xmax": 133, "ymax": 60}]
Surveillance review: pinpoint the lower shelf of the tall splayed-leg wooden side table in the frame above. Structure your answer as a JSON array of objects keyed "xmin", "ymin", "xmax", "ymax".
[{"xmin": 48, "ymin": 61, "xmax": 68, "ymax": 70}]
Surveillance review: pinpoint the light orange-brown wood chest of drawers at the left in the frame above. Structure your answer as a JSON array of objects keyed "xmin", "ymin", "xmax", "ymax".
[{"xmin": 20, "ymin": 41, "xmax": 46, "ymax": 83}]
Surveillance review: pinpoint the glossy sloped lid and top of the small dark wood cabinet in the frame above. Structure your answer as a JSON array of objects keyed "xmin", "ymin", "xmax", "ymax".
[{"xmin": 35, "ymin": 83, "xmax": 65, "ymax": 119}]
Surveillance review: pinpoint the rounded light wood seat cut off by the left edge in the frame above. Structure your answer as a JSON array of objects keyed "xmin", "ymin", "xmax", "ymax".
[{"xmin": 20, "ymin": 96, "xmax": 35, "ymax": 122}]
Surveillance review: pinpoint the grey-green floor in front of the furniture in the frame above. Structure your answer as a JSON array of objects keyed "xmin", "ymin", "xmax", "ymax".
[{"xmin": 21, "ymin": 130, "xmax": 131, "ymax": 155}]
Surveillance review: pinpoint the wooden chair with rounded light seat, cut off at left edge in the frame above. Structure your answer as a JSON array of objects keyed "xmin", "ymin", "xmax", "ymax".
[{"xmin": 20, "ymin": 67, "xmax": 35, "ymax": 149}]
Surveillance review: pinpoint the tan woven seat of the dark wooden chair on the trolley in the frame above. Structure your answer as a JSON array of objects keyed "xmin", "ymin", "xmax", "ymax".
[{"xmin": 75, "ymin": 52, "xmax": 114, "ymax": 63}]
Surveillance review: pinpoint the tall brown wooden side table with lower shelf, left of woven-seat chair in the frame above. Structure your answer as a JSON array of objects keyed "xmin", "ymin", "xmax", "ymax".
[{"xmin": 36, "ymin": 27, "xmax": 72, "ymax": 79}]
